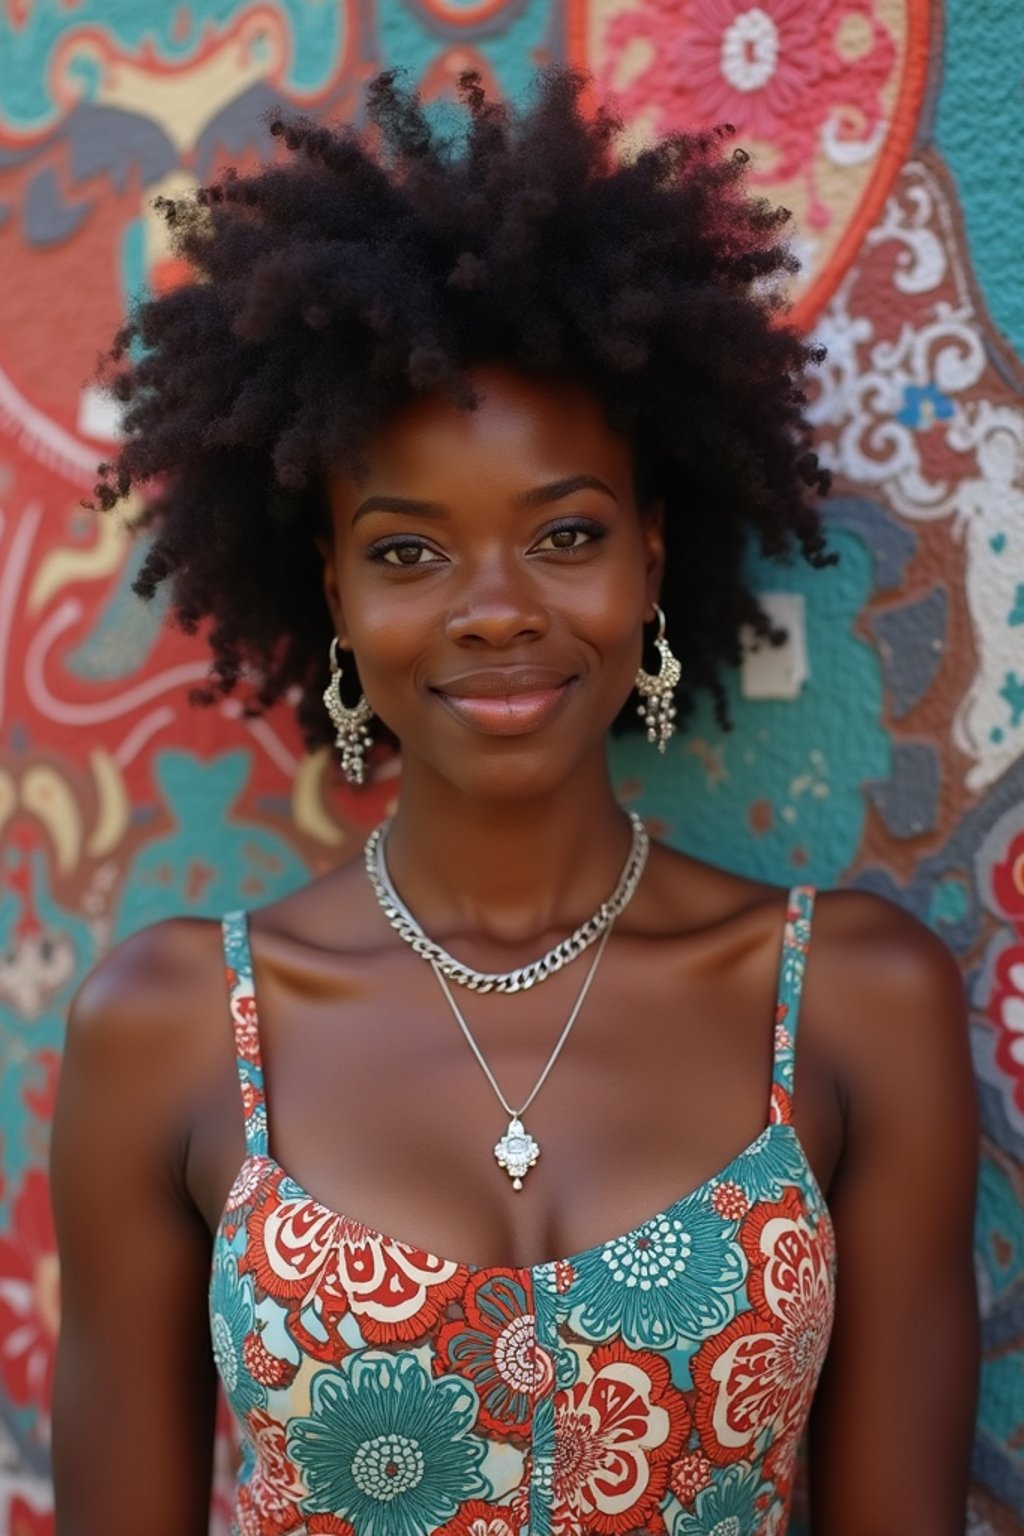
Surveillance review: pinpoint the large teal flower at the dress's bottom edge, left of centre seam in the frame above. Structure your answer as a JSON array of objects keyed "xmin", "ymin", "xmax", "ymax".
[{"xmin": 289, "ymin": 1353, "xmax": 493, "ymax": 1536}]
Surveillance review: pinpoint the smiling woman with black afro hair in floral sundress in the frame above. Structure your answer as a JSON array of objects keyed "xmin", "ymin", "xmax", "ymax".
[{"xmin": 54, "ymin": 72, "xmax": 976, "ymax": 1536}]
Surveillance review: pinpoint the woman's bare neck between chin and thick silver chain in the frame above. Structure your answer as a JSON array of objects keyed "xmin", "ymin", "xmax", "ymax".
[{"xmin": 385, "ymin": 756, "xmax": 631, "ymax": 945}]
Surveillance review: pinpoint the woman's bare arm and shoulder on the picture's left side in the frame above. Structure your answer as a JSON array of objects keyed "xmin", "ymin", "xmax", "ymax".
[{"xmin": 52, "ymin": 923, "xmax": 229, "ymax": 1536}]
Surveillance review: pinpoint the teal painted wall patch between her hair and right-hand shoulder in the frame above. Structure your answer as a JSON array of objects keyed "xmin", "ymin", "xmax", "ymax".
[{"xmin": 611, "ymin": 530, "xmax": 889, "ymax": 885}]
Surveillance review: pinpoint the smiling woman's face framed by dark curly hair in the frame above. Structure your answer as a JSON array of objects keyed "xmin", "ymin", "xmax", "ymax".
[{"xmin": 322, "ymin": 366, "xmax": 663, "ymax": 797}]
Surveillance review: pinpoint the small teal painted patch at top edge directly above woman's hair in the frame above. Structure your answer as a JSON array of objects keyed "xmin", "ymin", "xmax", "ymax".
[{"xmin": 376, "ymin": 0, "xmax": 551, "ymax": 97}]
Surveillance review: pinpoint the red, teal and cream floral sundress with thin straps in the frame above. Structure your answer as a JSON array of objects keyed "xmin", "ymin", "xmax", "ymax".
[{"xmin": 210, "ymin": 886, "xmax": 835, "ymax": 1536}]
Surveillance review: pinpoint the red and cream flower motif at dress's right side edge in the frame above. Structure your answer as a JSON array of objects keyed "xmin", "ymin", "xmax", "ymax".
[{"xmin": 692, "ymin": 1190, "xmax": 834, "ymax": 1482}]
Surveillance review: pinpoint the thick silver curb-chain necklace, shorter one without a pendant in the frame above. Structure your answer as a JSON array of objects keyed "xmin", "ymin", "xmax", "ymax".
[{"xmin": 364, "ymin": 811, "xmax": 651, "ymax": 992}]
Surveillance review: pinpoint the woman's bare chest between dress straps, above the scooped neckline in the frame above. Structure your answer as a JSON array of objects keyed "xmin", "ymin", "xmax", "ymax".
[{"xmin": 190, "ymin": 933, "xmax": 838, "ymax": 1266}]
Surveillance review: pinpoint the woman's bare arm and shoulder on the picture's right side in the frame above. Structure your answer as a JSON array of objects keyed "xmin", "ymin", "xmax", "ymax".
[{"xmin": 808, "ymin": 892, "xmax": 978, "ymax": 1536}]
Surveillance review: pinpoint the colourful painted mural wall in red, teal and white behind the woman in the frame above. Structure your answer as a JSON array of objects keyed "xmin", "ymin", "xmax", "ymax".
[{"xmin": 0, "ymin": 0, "xmax": 1024, "ymax": 1536}]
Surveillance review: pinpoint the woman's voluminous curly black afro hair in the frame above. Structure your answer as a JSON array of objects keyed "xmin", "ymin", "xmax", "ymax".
[{"xmin": 94, "ymin": 69, "xmax": 831, "ymax": 748}]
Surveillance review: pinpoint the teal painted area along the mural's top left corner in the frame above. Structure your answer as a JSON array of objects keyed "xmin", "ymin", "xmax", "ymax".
[{"xmin": 0, "ymin": 0, "xmax": 345, "ymax": 132}]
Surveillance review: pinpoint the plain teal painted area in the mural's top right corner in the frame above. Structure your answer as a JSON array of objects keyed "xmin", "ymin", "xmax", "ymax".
[{"xmin": 935, "ymin": 0, "xmax": 1024, "ymax": 356}]
